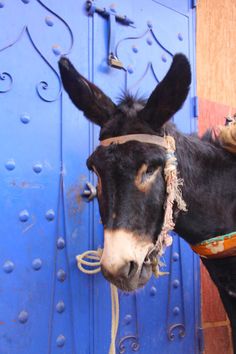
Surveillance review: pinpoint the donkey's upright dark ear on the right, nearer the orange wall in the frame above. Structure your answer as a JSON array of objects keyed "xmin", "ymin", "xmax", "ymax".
[{"xmin": 139, "ymin": 54, "xmax": 191, "ymax": 130}]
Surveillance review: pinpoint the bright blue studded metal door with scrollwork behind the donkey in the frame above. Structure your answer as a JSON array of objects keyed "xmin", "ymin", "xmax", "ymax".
[{"xmin": 0, "ymin": 0, "xmax": 200, "ymax": 354}]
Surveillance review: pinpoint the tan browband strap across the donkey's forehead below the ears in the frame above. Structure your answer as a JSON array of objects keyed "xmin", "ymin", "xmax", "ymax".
[{"xmin": 100, "ymin": 134, "xmax": 168, "ymax": 149}]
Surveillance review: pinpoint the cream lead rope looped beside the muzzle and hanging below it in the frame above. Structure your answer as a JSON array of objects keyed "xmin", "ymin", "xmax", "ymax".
[{"xmin": 76, "ymin": 248, "xmax": 119, "ymax": 354}]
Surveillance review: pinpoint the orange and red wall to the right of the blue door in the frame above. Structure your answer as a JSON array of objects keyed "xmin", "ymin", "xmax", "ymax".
[{"xmin": 197, "ymin": 0, "xmax": 236, "ymax": 354}]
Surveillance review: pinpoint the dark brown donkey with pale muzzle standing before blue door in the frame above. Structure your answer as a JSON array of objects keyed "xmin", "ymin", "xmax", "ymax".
[{"xmin": 59, "ymin": 54, "xmax": 236, "ymax": 353}]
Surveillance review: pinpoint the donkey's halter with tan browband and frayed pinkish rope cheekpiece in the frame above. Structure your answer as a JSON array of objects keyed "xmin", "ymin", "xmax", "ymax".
[{"xmin": 100, "ymin": 134, "xmax": 187, "ymax": 277}]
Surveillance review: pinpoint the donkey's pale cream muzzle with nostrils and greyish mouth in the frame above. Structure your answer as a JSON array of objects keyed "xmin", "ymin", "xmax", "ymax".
[{"xmin": 101, "ymin": 229, "xmax": 154, "ymax": 291}]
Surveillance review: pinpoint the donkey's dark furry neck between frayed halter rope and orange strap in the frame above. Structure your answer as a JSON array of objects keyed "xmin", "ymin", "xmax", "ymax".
[{"xmin": 172, "ymin": 131, "xmax": 236, "ymax": 244}]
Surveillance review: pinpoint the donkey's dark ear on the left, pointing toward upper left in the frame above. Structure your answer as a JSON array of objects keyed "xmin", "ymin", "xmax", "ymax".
[{"xmin": 59, "ymin": 57, "xmax": 116, "ymax": 127}]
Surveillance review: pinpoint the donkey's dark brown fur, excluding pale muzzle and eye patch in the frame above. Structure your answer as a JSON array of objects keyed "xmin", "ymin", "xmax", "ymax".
[{"xmin": 60, "ymin": 54, "xmax": 236, "ymax": 353}]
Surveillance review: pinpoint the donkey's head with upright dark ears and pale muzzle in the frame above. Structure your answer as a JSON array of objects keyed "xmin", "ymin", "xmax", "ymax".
[{"xmin": 59, "ymin": 54, "xmax": 191, "ymax": 291}]
